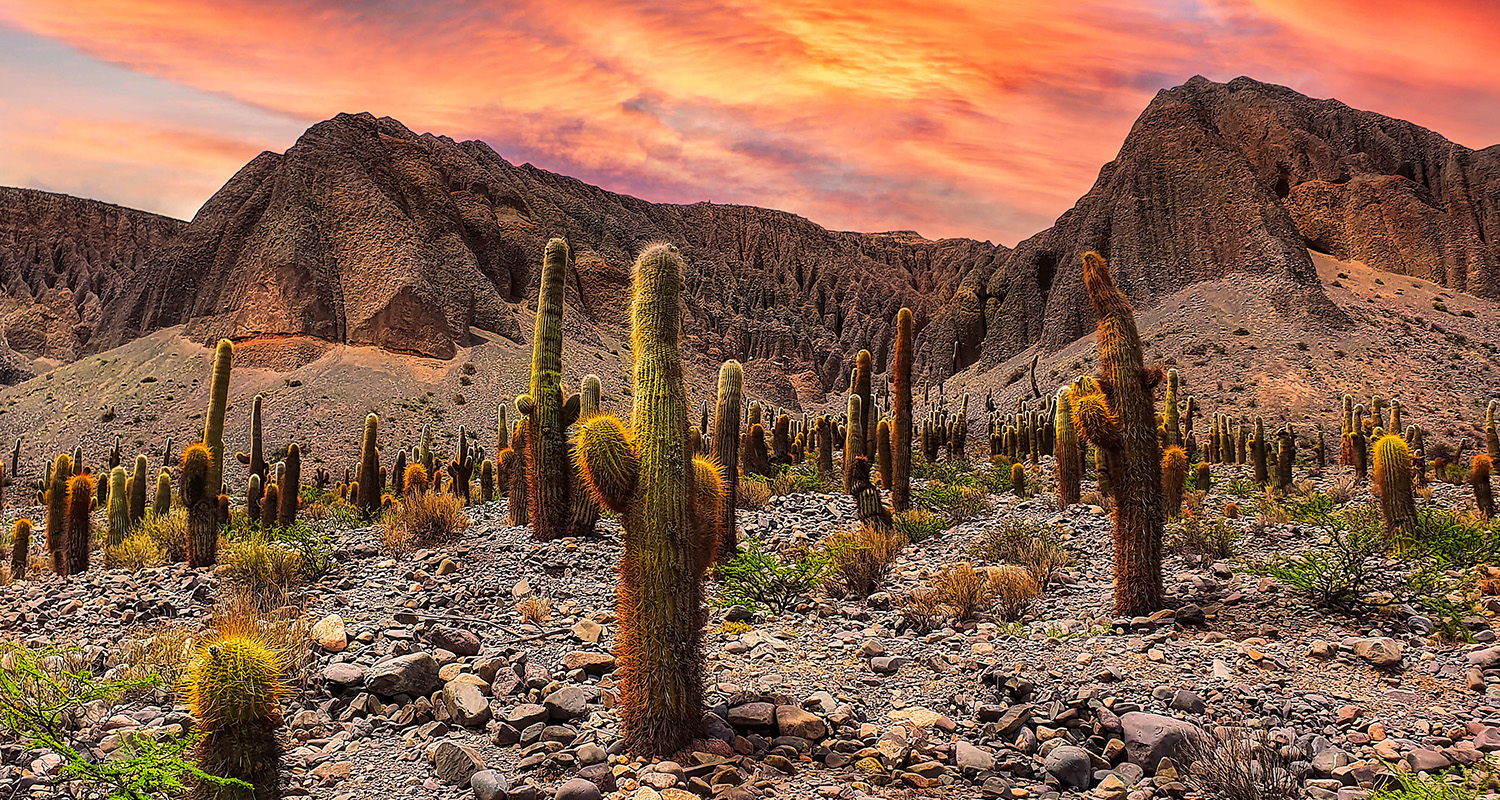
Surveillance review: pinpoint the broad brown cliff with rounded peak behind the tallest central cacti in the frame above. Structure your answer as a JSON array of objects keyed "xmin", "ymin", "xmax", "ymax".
[{"xmin": 99, "ymin": 114, "xmax": 1005, "ymax": 389}]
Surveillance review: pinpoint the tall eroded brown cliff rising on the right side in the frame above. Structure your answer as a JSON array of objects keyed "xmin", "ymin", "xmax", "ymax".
[{"xmin": 930, "ymin": 78, "xmax": 1500, "ymax": 373}]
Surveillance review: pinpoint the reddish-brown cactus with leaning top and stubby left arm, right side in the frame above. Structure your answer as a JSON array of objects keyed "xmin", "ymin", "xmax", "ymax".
[{"xmin": 1073, "ymin": 251, "xmax": 1164, "ymax": 617}]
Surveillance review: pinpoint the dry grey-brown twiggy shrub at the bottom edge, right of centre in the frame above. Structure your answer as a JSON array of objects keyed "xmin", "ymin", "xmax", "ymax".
[{"xmin": 1175, "ymin": 728, "xmax": 1301, "ymax": 800}]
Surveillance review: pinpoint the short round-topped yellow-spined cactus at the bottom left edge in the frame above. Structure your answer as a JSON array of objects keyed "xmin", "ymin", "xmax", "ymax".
[{"xmin": 182, "ymin": 626, "xmax": 287, "ymax": 800}]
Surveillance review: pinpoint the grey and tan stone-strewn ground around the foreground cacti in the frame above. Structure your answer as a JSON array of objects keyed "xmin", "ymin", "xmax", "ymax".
[{"xmin": 0, "ymin": 461, "xmax": 1500, "ymax": 800}]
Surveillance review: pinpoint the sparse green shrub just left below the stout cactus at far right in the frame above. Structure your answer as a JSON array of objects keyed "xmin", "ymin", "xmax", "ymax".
[{"xmin": 1260, "ymin": 525, "xmax": 1385, "ymax": 609}]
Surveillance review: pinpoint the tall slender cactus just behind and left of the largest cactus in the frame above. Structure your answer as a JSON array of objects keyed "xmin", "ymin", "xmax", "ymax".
[{"xmin": 516, "ymin": 239, "xmax": 582, "ymax": 540}]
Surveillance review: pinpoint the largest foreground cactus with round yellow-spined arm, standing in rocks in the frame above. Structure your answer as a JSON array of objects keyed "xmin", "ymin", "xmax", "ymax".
[{"xmin": 575, "ymin": 245, "xmax": 723, "ymax": 755}]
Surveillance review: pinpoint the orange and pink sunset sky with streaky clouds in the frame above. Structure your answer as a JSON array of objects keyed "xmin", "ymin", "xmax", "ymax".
[{"xmin": 0, "ymin": 0, "xmax": 1500, "ymax": 245}]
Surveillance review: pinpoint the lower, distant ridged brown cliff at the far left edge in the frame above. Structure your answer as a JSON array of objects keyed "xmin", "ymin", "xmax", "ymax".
[{"xmin": 0, "ymin": 188, "xmax": 186, "ymax": 384}]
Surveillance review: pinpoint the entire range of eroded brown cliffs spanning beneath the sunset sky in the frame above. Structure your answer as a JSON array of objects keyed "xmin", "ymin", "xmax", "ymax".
[{"xmin": 0, "ymin": 78, "xmax": 1500, "ymax": 395}]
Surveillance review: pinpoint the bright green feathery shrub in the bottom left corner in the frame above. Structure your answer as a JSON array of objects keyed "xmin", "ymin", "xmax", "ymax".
[{"xmin": 0, "ymin": 642, "xmax": 241, "ymax": 800}]
